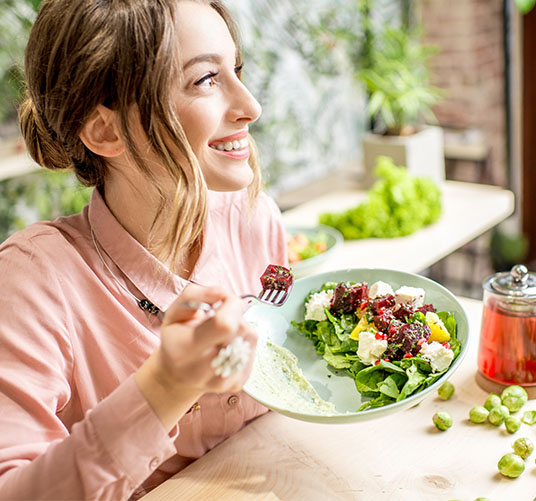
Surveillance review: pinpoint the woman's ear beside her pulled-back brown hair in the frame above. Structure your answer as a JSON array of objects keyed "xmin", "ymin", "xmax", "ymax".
[{"xmin": 80, "ymin": 104, "xmax": 126, "ymax": 158}]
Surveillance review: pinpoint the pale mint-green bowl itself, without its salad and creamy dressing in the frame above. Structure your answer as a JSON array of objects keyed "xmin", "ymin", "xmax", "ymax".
[{"xmin": 244, "ymin": 268, "xmax": 469, "ymax": 423}]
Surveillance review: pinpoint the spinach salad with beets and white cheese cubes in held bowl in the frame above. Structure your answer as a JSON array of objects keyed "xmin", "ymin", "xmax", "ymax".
[{"xmin": 291, "ymin": 281, "xmax": 461, "ymax": 411}]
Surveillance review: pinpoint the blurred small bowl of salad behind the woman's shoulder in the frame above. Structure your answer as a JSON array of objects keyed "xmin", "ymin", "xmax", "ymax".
[{"xmin": 286, "ymin": 225, "xmax": 344, "ymax": 278}]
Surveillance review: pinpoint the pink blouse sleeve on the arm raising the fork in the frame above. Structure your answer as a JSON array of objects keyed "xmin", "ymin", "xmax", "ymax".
[{"xmin": 0, "ymin": 235, "xmax": 180, "ymax": 500}]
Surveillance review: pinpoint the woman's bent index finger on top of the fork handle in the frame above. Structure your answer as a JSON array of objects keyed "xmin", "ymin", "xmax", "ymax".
[{"xmin": 163, "ymin": 284, "xmax": 229, "ymax": 325}]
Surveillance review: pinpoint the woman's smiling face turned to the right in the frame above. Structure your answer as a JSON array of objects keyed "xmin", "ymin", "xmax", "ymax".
[{"xmin": 171, "ymin": 1, "xmax": 261, "ymax": 191}]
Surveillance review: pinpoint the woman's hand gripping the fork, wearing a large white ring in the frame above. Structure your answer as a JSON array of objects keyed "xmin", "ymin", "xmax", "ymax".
[{"xmin": 134, "ymin": 285, "xmax": 257, "ymax": 429}]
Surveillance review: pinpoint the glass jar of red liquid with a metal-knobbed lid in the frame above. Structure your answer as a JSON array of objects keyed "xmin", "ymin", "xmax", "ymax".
[{"xmin": 478, "ymin": 264, "xmax": 536, "ymax": 386}]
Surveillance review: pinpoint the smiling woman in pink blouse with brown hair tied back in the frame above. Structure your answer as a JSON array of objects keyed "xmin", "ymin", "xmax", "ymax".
[{"xmin": 0, "ymin": 0, "xmax": 286, "ymax": 500}]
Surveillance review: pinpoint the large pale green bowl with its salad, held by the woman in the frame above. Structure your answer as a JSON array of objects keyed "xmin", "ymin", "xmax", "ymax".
[{"xmin": 244, "ymin": 268, "xmax": 469, "ymax": 423}]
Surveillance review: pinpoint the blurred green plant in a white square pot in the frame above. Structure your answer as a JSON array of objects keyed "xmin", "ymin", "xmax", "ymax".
[{"xmin": 356, "ymin": 28, "xmax": 445, "ymax": 187}]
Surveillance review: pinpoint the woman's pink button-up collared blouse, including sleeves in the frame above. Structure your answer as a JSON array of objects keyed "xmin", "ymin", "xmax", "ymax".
[{"xmin": 0, "ymin": 186, "xmax": 287, "ymax": 501}]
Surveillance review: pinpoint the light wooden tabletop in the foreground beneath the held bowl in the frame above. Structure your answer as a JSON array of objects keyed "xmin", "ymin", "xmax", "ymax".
[{"xmin": 143, "ymin": 299, "xmax": 536, "ymax": 501}]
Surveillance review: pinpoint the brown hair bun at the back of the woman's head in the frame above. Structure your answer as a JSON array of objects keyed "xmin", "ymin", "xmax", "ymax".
[{"xmin": 19, "ymin": 95, "xmax": 74, "ymax": 169}]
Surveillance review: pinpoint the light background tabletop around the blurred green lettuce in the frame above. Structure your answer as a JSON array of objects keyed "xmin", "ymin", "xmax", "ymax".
[{"xmin": 283, "ymin": 181, "xmax": 514, "ymax": 273}]
